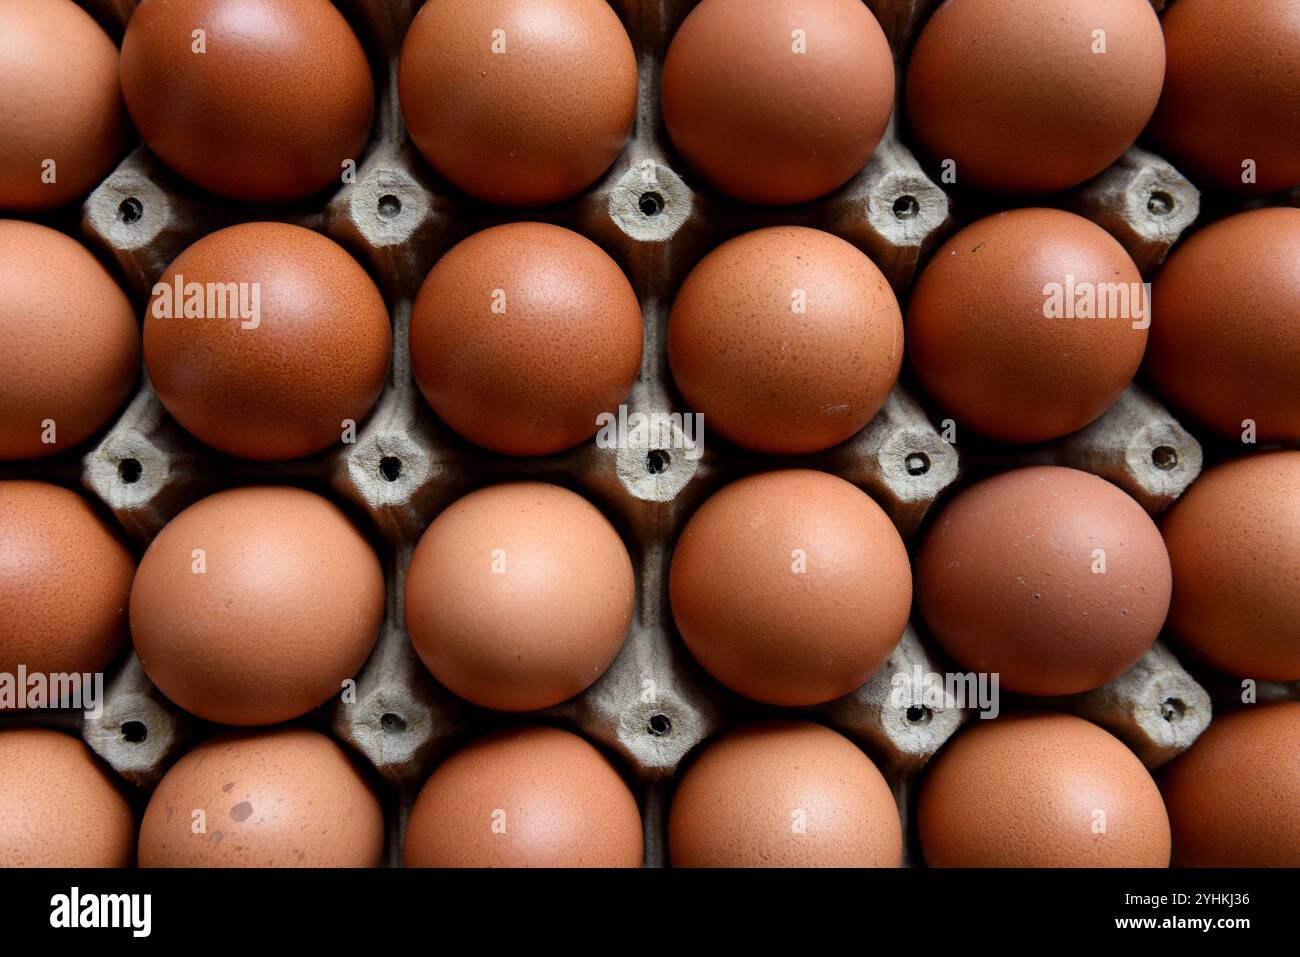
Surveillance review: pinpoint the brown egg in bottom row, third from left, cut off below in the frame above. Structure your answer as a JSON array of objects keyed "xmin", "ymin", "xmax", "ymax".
[{"xmin": 403, "ymin": 727, "xmax": 644, "ymax": 867}]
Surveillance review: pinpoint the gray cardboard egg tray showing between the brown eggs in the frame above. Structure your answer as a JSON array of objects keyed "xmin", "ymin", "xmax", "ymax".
[{"xmin": 0, "ymin": 0, "xmax": 1296, "ymax": 866}]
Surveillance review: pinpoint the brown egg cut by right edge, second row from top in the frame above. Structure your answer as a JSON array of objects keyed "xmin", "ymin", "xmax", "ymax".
[{"xmin": 1147, "ymin": 209, "xmax": 1300, "ymax": 441}]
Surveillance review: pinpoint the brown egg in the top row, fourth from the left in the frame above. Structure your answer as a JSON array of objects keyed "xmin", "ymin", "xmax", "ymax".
[{"xmin": 660, "ymin": 0, "xmax": 894, "ymax": 205}]
